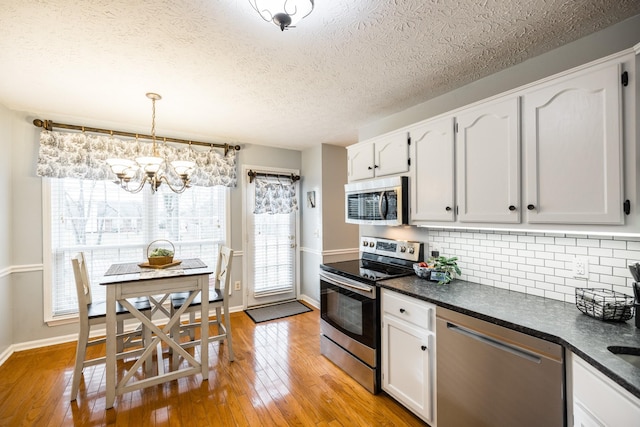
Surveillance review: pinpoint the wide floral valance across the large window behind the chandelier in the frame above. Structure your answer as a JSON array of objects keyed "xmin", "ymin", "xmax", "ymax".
[{"xmin": 37, "ymin": 130, "xmax": 237, "ymax": 187}]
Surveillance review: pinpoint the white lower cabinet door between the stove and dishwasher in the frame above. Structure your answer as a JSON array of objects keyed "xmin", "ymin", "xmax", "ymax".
[{"xmin": 382, "ymin": 316, "xmax": 435, "ymax": 423}]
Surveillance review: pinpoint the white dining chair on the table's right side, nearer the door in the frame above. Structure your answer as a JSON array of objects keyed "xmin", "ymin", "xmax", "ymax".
[{"xmin": 171, "ymin": 246, "xmax": 234, "ymax": 369}]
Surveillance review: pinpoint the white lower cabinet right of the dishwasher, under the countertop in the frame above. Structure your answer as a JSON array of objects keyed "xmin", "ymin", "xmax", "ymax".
[{"xmin": 567, "ymin": 353, "xmax": 640, "ymax": 427}]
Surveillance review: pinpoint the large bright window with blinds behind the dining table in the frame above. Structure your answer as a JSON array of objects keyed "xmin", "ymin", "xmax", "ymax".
[{"xmin": 43, "ymin": 178, "xmax": 229, "ymax": 320}]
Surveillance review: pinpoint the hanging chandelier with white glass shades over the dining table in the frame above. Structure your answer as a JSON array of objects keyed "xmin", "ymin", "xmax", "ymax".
[{"xmin": 106, "ymin": 93, "xmax": 195, "ymax": 193}]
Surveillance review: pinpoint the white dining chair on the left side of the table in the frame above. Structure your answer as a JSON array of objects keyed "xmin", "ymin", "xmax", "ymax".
[{"xmin": 70, "ymin": 252, "xmax": 151, "ymax": 401}]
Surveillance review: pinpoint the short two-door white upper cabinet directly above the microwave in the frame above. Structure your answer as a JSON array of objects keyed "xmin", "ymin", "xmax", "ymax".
[{"xmin": 347, "ymin": 130, "xmax": 409, "ymax": 182}]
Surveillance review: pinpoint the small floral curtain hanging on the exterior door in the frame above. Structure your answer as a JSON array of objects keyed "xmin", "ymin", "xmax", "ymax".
[{"xmin": 253, "ymin": 177, "xmax": 298, "ymax": 214}]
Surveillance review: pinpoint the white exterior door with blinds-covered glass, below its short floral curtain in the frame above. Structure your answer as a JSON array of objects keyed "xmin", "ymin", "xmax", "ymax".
[{"xmin": 245, "ymin": 171, "xmax": 299, "ymax": 307}]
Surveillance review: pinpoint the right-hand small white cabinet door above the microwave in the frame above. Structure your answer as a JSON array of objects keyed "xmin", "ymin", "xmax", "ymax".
[{"xmin": 374, "ymin": 131, "xmax": 409, "ymax": 176}]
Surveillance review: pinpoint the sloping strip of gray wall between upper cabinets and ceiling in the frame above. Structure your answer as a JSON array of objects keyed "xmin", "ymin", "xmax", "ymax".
[{"xmin": 359, "ymin": 15, "xmax": 640, "ymax": 140}]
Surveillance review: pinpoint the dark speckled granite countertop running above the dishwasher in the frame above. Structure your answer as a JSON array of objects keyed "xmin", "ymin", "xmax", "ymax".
[{"xmin": 378, "ymin": 276, "xmax": 640, "ymax": 398}]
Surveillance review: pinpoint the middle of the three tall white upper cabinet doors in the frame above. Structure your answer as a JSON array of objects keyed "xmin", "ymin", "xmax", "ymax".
[{"xmin": 456, "ymin": 98, "xmax": 520, "ymax": 223}]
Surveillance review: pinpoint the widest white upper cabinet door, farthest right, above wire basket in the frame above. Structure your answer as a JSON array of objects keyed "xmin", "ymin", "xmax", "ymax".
[{"xmin": 523, "ymin": 64, "xmax": 624, "ymax": 224}]
